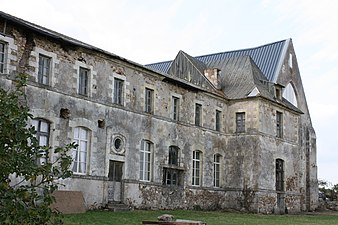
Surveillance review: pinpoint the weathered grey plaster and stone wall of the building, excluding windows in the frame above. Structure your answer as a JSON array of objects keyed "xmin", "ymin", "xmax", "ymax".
[{"xmin": 1, "ymin": 18, "xmax": 317, "ymax": 213}]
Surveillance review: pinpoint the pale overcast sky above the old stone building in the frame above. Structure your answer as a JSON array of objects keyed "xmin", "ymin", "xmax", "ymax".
[{"xmin": 0, "ymin": 0, "xmax": 338, "ymax": 183}]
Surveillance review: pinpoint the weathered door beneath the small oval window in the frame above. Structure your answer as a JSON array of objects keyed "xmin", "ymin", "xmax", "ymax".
[{"xmin": 108, "ymin": 160, "xmax": 123, "ymax": 202}]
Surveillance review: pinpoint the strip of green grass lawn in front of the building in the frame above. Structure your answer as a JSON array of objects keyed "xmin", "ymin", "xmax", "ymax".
[{"xmin": 64, "ymin": 210, "xmax": 338, "ymax": 225}]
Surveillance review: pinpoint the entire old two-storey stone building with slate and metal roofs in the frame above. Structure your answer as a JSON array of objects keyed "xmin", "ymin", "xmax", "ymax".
[{"xmin": 0, "ymin": 12, "xmax": 318, "ymax": 213}]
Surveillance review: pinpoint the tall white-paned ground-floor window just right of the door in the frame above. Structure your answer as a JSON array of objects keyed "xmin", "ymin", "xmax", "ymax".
[{"xmin": 140, "ymin": 141, "xmax": 152, "ymax": 181}]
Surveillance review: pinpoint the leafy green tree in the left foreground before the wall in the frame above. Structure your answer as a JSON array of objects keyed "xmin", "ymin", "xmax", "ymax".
[{"xmin": 0, "ymin": 76, "xmax": 76, "ymax": 224}]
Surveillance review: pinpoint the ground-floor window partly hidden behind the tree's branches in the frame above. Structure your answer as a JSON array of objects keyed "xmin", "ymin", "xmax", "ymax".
[{"xmin": 32, "ymin": 119, "xmax": 50, "ymax": 165}]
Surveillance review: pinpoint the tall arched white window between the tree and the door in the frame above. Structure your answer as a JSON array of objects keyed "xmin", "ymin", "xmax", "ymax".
[{"xmin": 72, "ymin": 127, "xmax": 89, "ymax": 174}]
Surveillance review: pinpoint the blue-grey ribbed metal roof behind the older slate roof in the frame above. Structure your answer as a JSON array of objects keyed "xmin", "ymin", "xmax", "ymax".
[{"xmin": 145, "ymin": 39, "xmax": 289, "ymax": 81}]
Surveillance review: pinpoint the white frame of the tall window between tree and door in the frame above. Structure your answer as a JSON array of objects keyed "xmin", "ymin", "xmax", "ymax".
[{"xmin": 72, "ymin": 126, "xmax": 90, "ymax": 175}]
